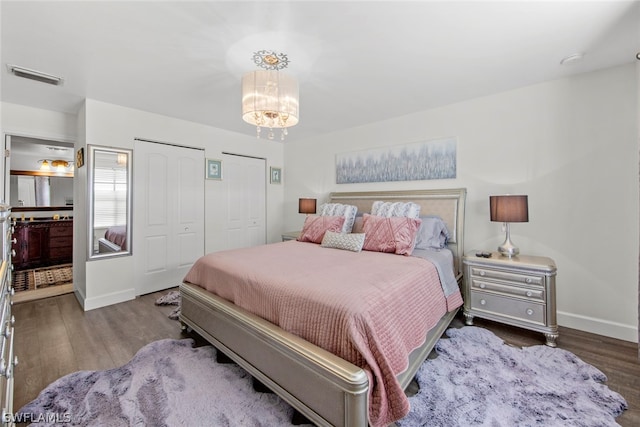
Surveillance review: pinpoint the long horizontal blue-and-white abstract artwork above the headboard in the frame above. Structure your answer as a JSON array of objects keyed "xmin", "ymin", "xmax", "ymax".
[{"xmin": 336, "ymin": 137, "xmax": 456, "ymax": 184}]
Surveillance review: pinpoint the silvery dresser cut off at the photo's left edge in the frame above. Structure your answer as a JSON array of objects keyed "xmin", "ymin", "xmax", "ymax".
[{"xmin": 0, "ymin": 204, "xmax": 18, "ymax": 426}]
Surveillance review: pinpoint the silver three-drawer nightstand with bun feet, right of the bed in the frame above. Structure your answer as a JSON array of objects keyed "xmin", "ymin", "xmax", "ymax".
[{"xmin": 462, "ymin": 252, "xmax": 558, "ymax": 347}]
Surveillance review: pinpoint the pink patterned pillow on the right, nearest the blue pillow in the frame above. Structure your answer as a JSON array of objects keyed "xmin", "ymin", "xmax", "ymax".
[{"xmin": 362, "ymin": 214, "xmax": 422, "ymax": 256}]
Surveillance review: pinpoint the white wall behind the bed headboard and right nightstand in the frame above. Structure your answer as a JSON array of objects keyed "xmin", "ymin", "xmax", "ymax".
[{"xmin": 284, "ymin": 65, "xmax": 639, "ymax": 341}]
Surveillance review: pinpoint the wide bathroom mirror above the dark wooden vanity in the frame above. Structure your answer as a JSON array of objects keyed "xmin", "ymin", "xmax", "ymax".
[{"xmin": 9, "ymin": 170, "xmax": 73, "ymax": 210}]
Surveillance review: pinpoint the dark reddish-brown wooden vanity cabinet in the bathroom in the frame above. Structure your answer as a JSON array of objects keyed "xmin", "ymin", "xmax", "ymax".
[{"xmin": 13, "ymin": 220, "xmax": 73, "ymax": 270}]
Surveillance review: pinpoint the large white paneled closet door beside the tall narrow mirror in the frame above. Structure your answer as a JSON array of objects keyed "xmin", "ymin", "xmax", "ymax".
[{"xmin": 133, "ymin": 141, "xmax": 204, "ymax": 295}]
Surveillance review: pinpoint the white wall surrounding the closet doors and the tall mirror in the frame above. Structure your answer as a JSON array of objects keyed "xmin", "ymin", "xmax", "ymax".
[{"xmin": 74, "ymin": 99, "xmax": 284, "ymax": 310}]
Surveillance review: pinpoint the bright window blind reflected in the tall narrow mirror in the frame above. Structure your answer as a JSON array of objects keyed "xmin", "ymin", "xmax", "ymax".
[{"xmin": 93, "ymin": 166, "xmax": 127, "ymax": 227}]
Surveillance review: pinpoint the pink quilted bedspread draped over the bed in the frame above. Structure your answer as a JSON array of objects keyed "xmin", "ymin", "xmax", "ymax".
[{"xmin": 185, "ymin": 241, "xmax": 462, "ymax": 426}]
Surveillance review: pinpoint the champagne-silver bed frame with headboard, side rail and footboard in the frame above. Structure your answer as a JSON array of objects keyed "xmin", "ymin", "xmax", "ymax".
[{"xmin": 180, "ymin": 188, "xmax": 466, "ymax": 427}]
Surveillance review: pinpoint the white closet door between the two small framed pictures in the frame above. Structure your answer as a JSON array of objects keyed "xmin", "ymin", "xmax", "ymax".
[{"xmin": 223, "ymin": 154, "xmax": 267, "ymax": 249}]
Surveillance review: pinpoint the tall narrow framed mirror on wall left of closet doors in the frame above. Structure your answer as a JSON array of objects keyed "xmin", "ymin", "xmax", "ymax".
[{"xmin": 87, "ymin": 145, "xmax": 132, "ymax": 259}]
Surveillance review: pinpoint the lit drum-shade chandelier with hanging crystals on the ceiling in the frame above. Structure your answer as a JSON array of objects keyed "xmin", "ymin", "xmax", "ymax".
[{"xmin": 242, "ymin": 50, "xmax": 299, "ymax": 141}]
